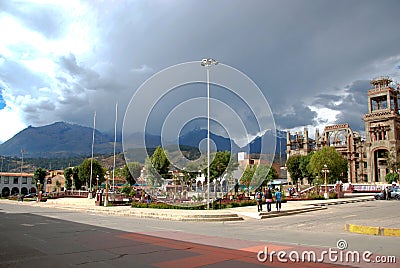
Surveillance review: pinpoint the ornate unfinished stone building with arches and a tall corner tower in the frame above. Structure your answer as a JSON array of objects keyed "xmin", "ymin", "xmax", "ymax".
[{"xmin": 286, "ymin": 77, "xmax": 400, "ymax": 182}]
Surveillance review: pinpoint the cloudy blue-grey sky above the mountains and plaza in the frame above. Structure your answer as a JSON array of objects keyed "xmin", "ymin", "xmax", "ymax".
[{"xmin": 0, "ymin": 0, "xmax": 400, "ymax": 142}]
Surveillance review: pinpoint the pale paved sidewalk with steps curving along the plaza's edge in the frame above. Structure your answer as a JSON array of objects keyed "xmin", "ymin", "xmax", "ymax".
[{"xmin": 0, "ymin": 196, "xmax": 382, "ymax": 223}]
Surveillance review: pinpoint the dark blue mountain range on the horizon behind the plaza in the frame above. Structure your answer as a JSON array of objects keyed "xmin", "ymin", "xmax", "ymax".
[{"xmin": 0, "ymin": 122, "xmax": 286, "ymax": 158}]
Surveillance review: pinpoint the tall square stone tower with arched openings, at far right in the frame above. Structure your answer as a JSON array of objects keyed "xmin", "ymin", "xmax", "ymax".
[{"xmin": 363, "ymin": 77, "xmax": 400, "ymax": 182}]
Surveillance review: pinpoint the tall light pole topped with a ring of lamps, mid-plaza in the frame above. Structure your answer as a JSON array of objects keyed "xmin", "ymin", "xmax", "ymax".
[{"xmin": 201, "ymin": 59, "xmax": 218, "ymax": 209}]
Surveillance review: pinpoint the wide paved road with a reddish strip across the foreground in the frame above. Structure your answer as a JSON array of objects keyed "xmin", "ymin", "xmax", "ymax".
[{"xmin": 0, "ymin": 201, "xmax": 400, "ymax": 267}]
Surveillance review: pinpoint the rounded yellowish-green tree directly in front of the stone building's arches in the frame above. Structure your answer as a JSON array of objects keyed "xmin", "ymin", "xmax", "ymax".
[{"xmin": 309, "ymin": 146, "xmax": 348, "ymax": 183}]
